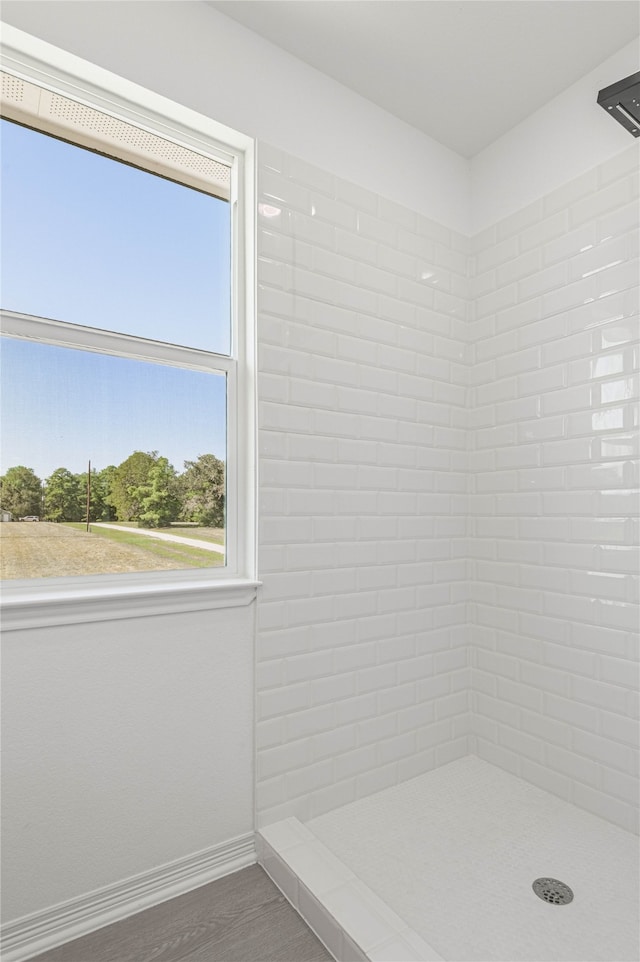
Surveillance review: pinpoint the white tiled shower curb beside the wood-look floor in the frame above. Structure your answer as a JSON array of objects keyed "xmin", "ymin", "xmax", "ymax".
[{"xmin": 256, "ymin": 818, "xmax": 444, "ymax": 962}]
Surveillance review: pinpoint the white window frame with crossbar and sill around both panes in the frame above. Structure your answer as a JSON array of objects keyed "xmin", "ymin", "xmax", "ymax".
[{"xmin": 0, "ymin": 24, "xmax": 259, "ymax": 630}]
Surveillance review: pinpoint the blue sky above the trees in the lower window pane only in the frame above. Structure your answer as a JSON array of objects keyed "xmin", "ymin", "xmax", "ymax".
[{"xmin": 0, "ymin": 338, "xmax": 226, "ymax": 480}]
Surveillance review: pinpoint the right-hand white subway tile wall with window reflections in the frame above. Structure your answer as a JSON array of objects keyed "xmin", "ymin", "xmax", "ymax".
[{"xmin": 469, "ymin": 144, "xmax": 640, "ymax": 831}]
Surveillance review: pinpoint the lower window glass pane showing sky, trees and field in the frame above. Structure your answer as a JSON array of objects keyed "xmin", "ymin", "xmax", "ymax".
[{"xmin": 0, "ymin": 338, "xmax": 227, "ymax": 578}]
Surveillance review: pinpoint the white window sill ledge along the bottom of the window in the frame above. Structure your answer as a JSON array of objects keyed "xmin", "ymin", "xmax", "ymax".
[{"xmin": 0, "ymin": 572, "xmax": 260, "ymax": 632}]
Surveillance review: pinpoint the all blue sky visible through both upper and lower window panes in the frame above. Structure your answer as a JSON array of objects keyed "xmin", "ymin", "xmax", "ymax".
[{"xmin": 0, "ymin": 121, "xmax": 230, "ymax": 478}]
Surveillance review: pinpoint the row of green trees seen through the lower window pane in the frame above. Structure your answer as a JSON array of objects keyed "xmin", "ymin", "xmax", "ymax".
[{"xmin": 0, "ymin": 451, "xmax": 225, "ymax": 528}]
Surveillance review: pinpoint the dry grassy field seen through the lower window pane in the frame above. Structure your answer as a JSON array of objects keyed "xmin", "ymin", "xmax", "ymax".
[{"xmin": 0, "ymin": 521, "xmax": 224, "ymax": 579}]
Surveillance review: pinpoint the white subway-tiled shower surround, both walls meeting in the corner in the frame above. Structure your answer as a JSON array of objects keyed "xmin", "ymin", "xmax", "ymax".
[{"xmin": 252, "ymin": 145, "xmax": 640, "ymax": 958}]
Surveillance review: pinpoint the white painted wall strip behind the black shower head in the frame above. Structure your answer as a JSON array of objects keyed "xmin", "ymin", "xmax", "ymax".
[{"xmin": 470, "ymin": 37, "xmax": 640, "ymax": 234}]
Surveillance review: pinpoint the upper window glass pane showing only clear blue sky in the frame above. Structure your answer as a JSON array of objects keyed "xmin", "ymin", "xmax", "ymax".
[{"xmin": 1, "ymin": 120, "xmax": 231, "ymax": 354}]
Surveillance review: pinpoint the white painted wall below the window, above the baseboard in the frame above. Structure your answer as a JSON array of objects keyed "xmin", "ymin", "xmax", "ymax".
[{"xmin": 2, "ymin": 606, "xmax": 255, "ymax": 921}]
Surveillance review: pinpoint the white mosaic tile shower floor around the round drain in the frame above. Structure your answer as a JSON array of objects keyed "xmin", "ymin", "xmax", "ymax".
[{"xmin": 306, "ymin": 756, "xmax": 640, "ymax": 962}]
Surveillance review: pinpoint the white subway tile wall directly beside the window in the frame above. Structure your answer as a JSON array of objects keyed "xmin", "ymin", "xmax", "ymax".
[{"xmin": 257, "ymin": 145, "xmax": 470, "ymax": 825}]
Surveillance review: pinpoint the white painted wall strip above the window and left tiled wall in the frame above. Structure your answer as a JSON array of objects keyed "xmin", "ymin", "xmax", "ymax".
[{"xmin": 2, "ymin": 0, "xmax": 469, "ymax": 232}]
